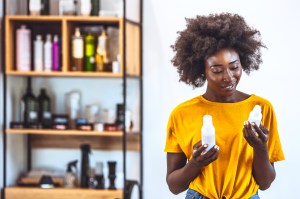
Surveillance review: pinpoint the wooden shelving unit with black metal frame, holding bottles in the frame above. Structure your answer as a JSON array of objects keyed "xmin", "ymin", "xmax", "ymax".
[{"xmin": 1, "ymin": 0, "xmax": 143, "ymax": 199}]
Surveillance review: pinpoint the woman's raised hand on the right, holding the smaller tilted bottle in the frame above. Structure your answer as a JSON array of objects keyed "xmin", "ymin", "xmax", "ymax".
[{"xmin": 243, "ymin": 121, "xmax": 269, "ymax": 149}]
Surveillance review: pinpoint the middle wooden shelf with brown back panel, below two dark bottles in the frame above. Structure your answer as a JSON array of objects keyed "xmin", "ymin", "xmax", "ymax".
[{"xmin": 6, "ymin": 129, "xmax": 141, "ymax": 151}]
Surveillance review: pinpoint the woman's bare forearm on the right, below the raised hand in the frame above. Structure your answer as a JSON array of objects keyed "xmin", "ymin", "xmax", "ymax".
[{"xmin": 253, "ymin": 146, "xmax": 276, "ymax": 190}]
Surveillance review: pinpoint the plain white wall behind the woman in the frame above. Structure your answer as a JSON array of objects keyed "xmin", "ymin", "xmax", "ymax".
[{"xmin": 144, "ymin": 0, "xmax": 300, "ymax": 199}]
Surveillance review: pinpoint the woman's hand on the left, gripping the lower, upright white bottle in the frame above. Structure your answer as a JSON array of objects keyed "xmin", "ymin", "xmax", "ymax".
[{"xmin": 190, "ymin": 141, "xmax": 220, "ymax": 168}]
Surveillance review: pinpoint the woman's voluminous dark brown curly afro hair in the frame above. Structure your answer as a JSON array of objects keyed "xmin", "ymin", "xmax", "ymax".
[{"xmin": 171, "ymin": 13, "xmax": 266, "ymax": 87}]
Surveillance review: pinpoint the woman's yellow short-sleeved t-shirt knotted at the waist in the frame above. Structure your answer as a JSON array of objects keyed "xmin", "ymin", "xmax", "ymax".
[{"xmin": 165, "ymin": 95, "xmax": 284, "ymax": 199}]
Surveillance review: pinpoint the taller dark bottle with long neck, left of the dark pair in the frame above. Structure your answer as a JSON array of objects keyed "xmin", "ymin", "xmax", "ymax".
[{"xmin": 21, "ymin": 78, "xmax": 38, "ymax": 128}]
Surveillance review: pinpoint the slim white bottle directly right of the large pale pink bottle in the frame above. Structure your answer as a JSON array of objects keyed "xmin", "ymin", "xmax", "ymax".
[{"xmin": 33, "ymin": 35, "xmax": 44, "ymax": 71}]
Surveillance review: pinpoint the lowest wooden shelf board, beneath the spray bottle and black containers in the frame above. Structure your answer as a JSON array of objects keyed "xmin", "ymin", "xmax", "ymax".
[{"xmin": 5, "ymin": 187, "xmax": 123, "ymax": 199}]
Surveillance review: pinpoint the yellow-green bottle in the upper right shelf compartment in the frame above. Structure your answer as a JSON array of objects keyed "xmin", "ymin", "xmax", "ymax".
[{"xmin": 84, "ymin": 32, "xmax": 95, "ymax": 71}]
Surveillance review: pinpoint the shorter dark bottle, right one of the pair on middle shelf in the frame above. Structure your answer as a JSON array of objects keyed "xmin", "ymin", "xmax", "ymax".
[{"xmin": 37, "ymin": 88, "xmax": 52, "ymax": 129}]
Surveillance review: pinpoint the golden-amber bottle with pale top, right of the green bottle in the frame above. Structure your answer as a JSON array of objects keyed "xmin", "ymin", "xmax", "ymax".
[{"xmin": 96, "ymin": 30, "xmax": 108, "ymax": 71}]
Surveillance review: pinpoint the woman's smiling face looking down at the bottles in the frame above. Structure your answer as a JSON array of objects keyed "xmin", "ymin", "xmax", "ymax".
[{"xmin": 205, "ymin": 48, "xmax": 242, "ymax": 101}]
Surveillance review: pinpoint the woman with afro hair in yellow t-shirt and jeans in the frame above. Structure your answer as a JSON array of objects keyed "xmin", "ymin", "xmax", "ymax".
[{"xmin": 165, "ymin": 13, "xmax": 284, "ymax": 199}]
